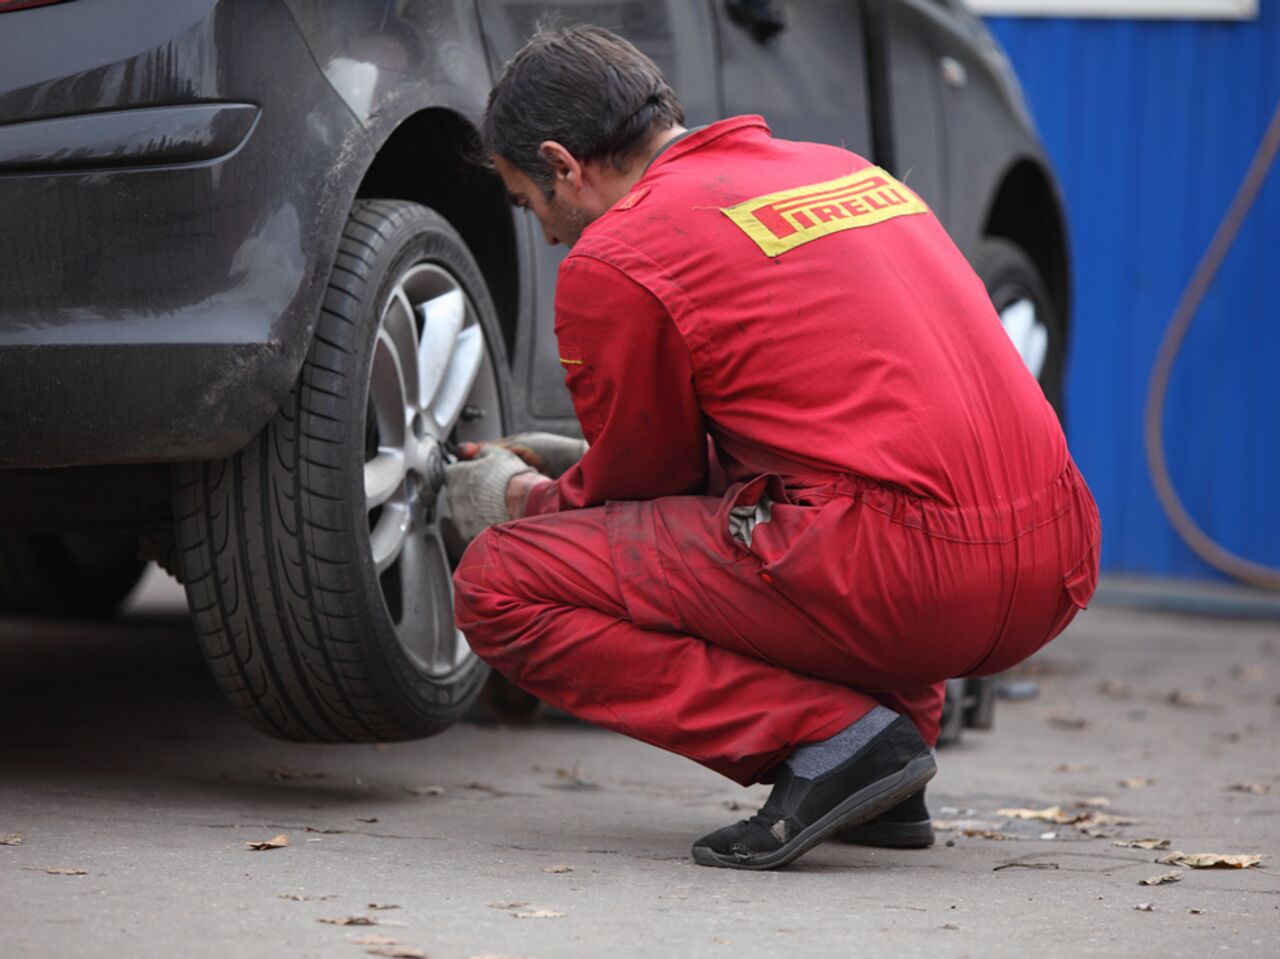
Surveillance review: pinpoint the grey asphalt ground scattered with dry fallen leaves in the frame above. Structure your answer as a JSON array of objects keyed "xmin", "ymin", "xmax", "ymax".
[{"xmin": 0, "ymin": 568, "xmax": 1280, "ymax": 959}]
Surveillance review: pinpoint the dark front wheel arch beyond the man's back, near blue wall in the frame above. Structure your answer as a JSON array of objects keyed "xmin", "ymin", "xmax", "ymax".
[{"xmin": 983, "ymin": 157, "xmax": 1071, "ymax": 342}]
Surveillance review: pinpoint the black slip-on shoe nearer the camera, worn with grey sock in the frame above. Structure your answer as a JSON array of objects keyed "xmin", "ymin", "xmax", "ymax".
[{"xmin": 692, "ymin": 716, "xmax": 938, "ymax": 869}]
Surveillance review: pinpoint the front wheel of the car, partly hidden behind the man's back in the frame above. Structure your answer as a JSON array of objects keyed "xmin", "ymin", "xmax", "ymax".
[{"xmin": 970, "ymin": 237, "xmax": 1066, "ymax": 420}]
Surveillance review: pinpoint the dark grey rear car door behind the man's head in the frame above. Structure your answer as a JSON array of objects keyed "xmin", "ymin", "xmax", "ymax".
[{"xmin": 476, "ymin": 0, "xmax": 719, "ymax": 431}]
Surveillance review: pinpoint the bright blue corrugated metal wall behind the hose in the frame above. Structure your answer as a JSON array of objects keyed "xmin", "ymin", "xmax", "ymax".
[{"xmin": 991, "ymin": 0, "xmax": 1280, "ymax": 576}]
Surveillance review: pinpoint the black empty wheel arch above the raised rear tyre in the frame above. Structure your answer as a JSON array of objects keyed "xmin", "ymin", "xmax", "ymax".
[{"xmin": 356, "ymin": 106, "xmax": 520, "ymax": 356}]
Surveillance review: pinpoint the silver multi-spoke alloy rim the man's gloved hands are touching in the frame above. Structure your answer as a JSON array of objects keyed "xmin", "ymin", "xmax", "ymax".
[{"xmin": 364, "ymin": 262, "xmax": 502, "ymax": 677}]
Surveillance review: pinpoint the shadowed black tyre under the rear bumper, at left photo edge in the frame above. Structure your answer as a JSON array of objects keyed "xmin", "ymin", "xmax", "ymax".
[{"xmin": 0, "ymin": 530, "xmax": 146, "ymax": 620}]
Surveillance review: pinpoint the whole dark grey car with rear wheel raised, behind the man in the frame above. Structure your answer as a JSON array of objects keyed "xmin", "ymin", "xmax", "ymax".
[{"xmin": 0, "ymin": 0, "xmax": 1069, "ymax": 740}]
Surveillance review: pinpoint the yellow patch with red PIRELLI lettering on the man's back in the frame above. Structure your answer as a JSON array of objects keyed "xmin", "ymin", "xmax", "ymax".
[{"xmin": 721, "ymin": 166, "xmax": 929, "ymax": 256}]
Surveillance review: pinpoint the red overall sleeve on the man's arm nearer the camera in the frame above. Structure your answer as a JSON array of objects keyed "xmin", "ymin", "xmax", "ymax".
[{"xmin": 525, "ymin": 250, "xmax": 707, "ymax": 516}]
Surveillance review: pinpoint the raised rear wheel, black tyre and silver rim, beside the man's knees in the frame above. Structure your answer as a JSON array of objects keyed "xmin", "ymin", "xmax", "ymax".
[{"xmin": 175, "ymin": 200, "xmax": 508, "ymax": 741}]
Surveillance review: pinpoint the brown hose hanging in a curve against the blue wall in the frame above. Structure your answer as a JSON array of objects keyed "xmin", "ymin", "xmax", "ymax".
[{"xmin": 1144, "ymin": 102, "xmax": 1280, "ymax": 590}]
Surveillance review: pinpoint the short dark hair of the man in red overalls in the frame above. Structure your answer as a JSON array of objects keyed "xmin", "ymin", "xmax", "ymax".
[{"xmin": 480, "ymin": 26, "xmax": 685, "ymax": 197}]
